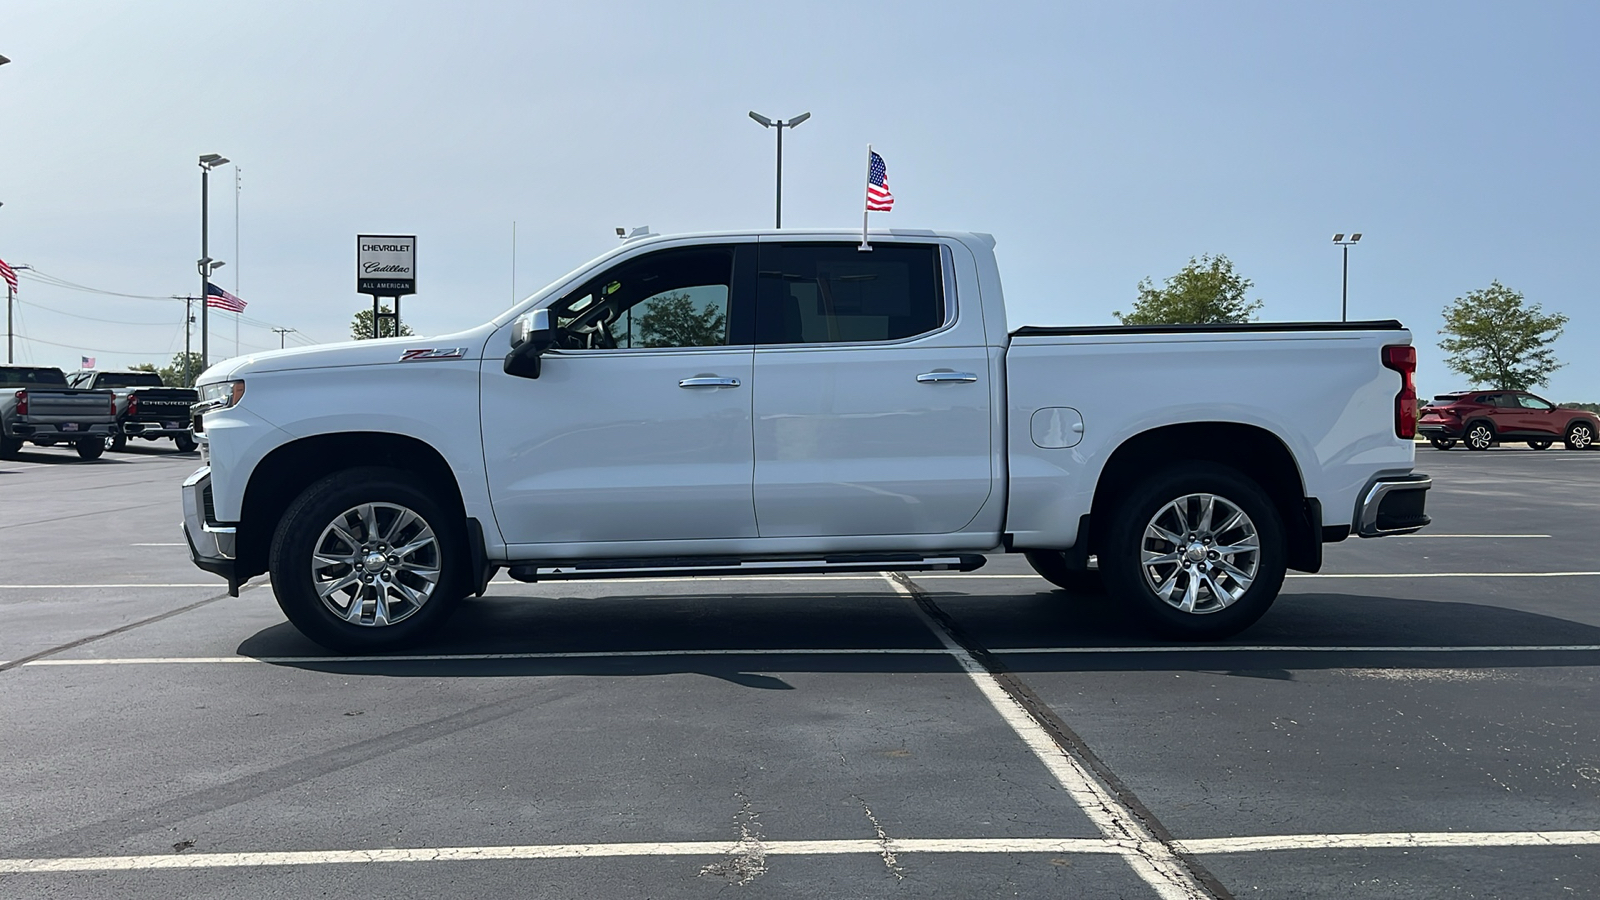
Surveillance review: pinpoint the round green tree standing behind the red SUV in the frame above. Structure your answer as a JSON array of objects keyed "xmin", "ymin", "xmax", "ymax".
[{"xmin": 1438, "ymin": 280, "xmax": 1566, "ymax": 391}]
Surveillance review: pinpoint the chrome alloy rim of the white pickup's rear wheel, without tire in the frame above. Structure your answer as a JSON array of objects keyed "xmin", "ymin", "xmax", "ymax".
[{"xmin": 1139, "ymin": 493, "xmax": 1261, "ymax": 615}]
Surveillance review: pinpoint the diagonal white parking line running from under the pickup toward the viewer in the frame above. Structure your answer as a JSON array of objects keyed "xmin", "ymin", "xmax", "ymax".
[{"xmin": 885, "ymin": 575, "xmax": 1210, "ymax": 900}]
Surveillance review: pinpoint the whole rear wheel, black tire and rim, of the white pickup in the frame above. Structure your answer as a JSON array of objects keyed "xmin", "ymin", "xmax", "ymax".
[{"xmin": 1099, "ymin": 463, "xmax": 1288, "ymax": 641}]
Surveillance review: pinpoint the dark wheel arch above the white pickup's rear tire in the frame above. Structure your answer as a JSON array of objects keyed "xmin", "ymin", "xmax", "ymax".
[{"xmin": 1090, "ymin": 421, "xmax": 1323, "ymax": 572}]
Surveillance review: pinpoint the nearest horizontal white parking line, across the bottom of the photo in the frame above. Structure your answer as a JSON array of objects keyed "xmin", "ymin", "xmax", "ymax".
[{"xmin": 0, "ymin": 831, "xmax": 1600, "ymax": 874}]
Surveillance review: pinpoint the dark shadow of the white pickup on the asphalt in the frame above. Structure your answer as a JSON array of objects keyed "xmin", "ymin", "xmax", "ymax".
[{"xmin": 238, "ymin": 591, "xmax": 1600, "ymax": 675}]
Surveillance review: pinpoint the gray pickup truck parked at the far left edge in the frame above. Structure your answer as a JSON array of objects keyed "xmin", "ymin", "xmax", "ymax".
[{"xmin": 0, "ymin": 365, "xmax": 117, "ymax": 460}]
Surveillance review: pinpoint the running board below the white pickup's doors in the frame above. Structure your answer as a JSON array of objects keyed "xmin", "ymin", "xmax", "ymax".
[{"xmin": 506, "ymin": 552, "xmax": 989, "ymax": 581}]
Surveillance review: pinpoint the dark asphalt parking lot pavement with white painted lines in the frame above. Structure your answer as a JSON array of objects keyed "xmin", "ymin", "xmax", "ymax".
[{"xmin": 0, "ymin": 444, "xmax": 1600, "ymax": 898}]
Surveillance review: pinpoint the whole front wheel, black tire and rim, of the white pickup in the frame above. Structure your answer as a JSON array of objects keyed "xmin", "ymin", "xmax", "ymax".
[{"xmin": 269, "ymin": 468, "xmax": 467, "ymax": 653}]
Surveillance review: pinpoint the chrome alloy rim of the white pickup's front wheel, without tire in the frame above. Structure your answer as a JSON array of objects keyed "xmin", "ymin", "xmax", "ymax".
[{"xmin": 310, "ymin": 503, "xmax": 443, "ymax": 628}]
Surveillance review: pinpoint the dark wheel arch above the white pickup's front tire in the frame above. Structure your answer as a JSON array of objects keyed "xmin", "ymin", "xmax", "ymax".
[{"xmin": 237, "ymin": 431, "xmax": 467, "ymax": 581}]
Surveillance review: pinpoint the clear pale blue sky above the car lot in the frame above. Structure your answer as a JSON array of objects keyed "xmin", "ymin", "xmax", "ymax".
[{"xmin": 0, "ymin": 0, "xmax": 1600, "ymax": 395}]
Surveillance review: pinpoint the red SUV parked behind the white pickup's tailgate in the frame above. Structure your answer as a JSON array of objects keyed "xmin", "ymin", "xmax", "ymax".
[{"xmin": 1416, "ymin": 391, "xmax": 1600, "ymax": 450}]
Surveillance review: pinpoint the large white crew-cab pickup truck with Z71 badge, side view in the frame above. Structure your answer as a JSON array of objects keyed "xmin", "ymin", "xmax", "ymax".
[{"xmin": 182, "ymin": 231, "xmax": 1430, "ymax": 650}]
